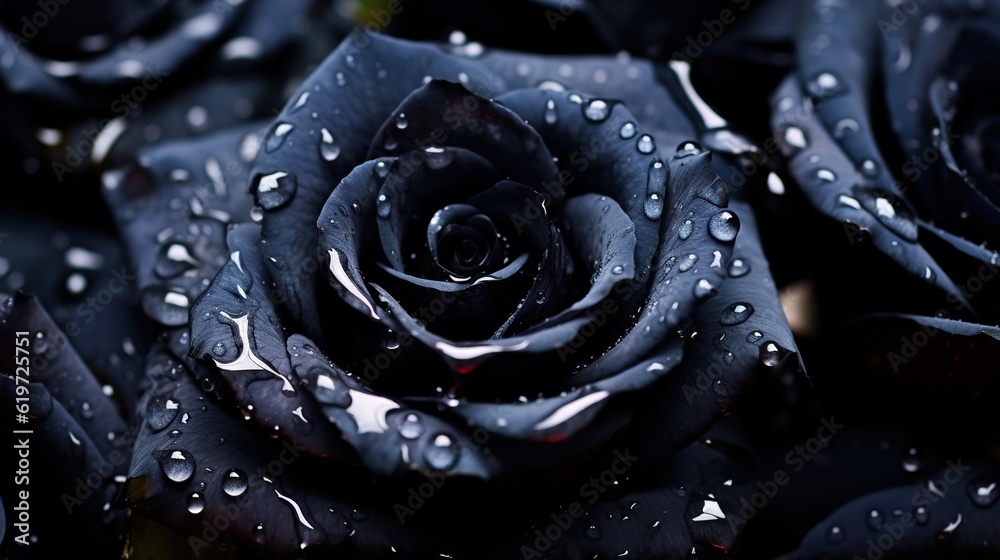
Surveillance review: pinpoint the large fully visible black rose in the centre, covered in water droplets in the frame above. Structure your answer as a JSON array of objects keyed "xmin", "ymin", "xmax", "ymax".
[{"xmin": 105, "ymin": 32, "xmax": 797, "ymax": 555}]
